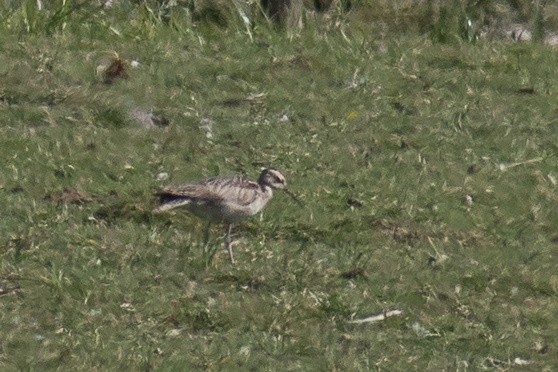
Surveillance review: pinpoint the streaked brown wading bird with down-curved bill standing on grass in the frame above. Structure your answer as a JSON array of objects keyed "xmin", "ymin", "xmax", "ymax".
[{"xmin": 153, "ymin": 168, "xmax": 302, "ymax": 264}]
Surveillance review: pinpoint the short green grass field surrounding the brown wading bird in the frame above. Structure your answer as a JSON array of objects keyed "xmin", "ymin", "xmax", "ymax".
[{"xmin": 0, "ymin": 1, "xmax": 558, "ymax": 371}]
